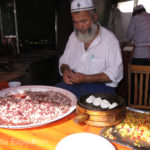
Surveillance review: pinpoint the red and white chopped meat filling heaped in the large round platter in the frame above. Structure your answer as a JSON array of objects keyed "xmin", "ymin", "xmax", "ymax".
[{"xmin": 0, "ymin": 90, "xmax": 72, "ymax": 125}]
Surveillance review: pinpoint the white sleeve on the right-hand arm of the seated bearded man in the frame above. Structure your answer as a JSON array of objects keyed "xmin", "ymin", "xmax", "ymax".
[{"xmin": 104, "ymin": 37, "xmax": 123, "ymax": 87}]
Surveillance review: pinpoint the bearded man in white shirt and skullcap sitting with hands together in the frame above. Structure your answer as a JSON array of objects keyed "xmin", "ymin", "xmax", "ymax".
[{"xmin": 56, "ymin": 0, "xmax": 123, "ymax": 98}]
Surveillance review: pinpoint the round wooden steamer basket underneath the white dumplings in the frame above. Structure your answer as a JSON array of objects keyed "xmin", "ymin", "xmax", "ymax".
[{"xmin": 75, "ymin": 93, "xmax": 126, "ymax": 127}]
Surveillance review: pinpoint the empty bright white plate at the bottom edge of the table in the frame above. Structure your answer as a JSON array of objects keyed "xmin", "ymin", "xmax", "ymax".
[{"xmin": 55, "ymin": 133, "xmax": 115, "ymax": 150}]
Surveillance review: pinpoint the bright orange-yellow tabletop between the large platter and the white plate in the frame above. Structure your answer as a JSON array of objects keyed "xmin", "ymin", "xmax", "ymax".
[{"xmin": 0, "ymin": 112, "xmax": 133, "ymax": 150}]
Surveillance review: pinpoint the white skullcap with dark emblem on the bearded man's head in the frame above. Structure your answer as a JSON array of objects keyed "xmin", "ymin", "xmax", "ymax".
[{"xmin": 71, "ymin": 0, "xmax": 96, "ymax": 12}]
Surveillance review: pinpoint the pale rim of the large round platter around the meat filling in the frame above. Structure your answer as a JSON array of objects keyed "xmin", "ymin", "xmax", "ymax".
[{"xmin": 0, "ymin": 85, "xmax": 77, "ymax": 129}]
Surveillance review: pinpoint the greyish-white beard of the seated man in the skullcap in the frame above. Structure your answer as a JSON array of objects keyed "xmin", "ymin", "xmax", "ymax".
[{"xmin": 74, "ymin": 23, "xmax": 98, "ymax": 43}]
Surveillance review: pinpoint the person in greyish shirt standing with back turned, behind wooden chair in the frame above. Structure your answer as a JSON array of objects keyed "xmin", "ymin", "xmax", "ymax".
[{"xmin": 122, "ymin": 5, "xmax": 150, "ymax": 65}]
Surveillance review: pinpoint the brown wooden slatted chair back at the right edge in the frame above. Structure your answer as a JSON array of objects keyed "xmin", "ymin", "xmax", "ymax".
[{"xmin": 128, "ymin": 64, "xmax": 150, "ymax": 109}]
